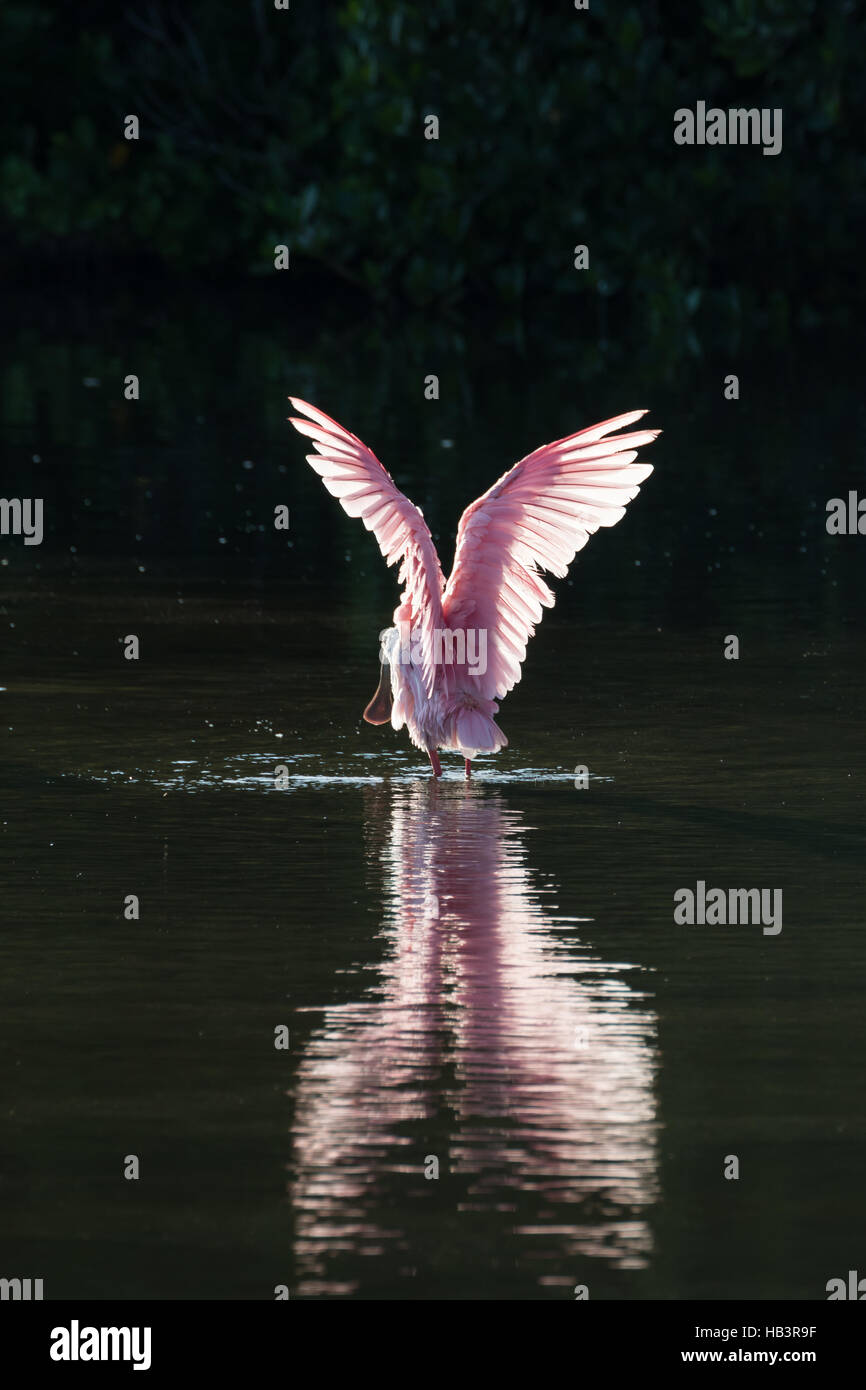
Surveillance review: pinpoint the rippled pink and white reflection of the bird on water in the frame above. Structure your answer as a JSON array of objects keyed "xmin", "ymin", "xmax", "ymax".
[{"xmin": 292, "ymin": 781, "xmax": 656, "ymax": 1295}]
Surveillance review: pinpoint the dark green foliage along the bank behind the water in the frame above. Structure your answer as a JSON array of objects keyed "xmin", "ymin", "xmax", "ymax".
[{"xmin": 0, "ymin": 0, "xmax": 866, "ymax": 336}]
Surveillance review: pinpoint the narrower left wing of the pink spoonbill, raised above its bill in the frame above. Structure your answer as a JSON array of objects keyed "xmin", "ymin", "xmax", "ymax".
[{"xmin": 289, "ymin": 396, "xmax": 445, "ymax": 695}]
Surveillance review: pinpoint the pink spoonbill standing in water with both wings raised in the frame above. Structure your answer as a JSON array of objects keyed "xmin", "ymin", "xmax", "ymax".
[{"xmin": 289, "ymin": 396, "xmax": 660, "ymax": 777}]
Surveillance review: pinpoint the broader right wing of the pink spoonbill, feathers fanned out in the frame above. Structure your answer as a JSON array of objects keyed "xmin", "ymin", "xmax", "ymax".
[{"xmin": 442, "ymin": 410, "xmax": 660, "ymax": 699}]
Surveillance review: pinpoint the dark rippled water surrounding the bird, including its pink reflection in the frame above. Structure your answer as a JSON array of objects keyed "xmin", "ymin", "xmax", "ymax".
[{"xmin": 0, "ymin": 287, "xmax": 866, "ymax": 1298}]
